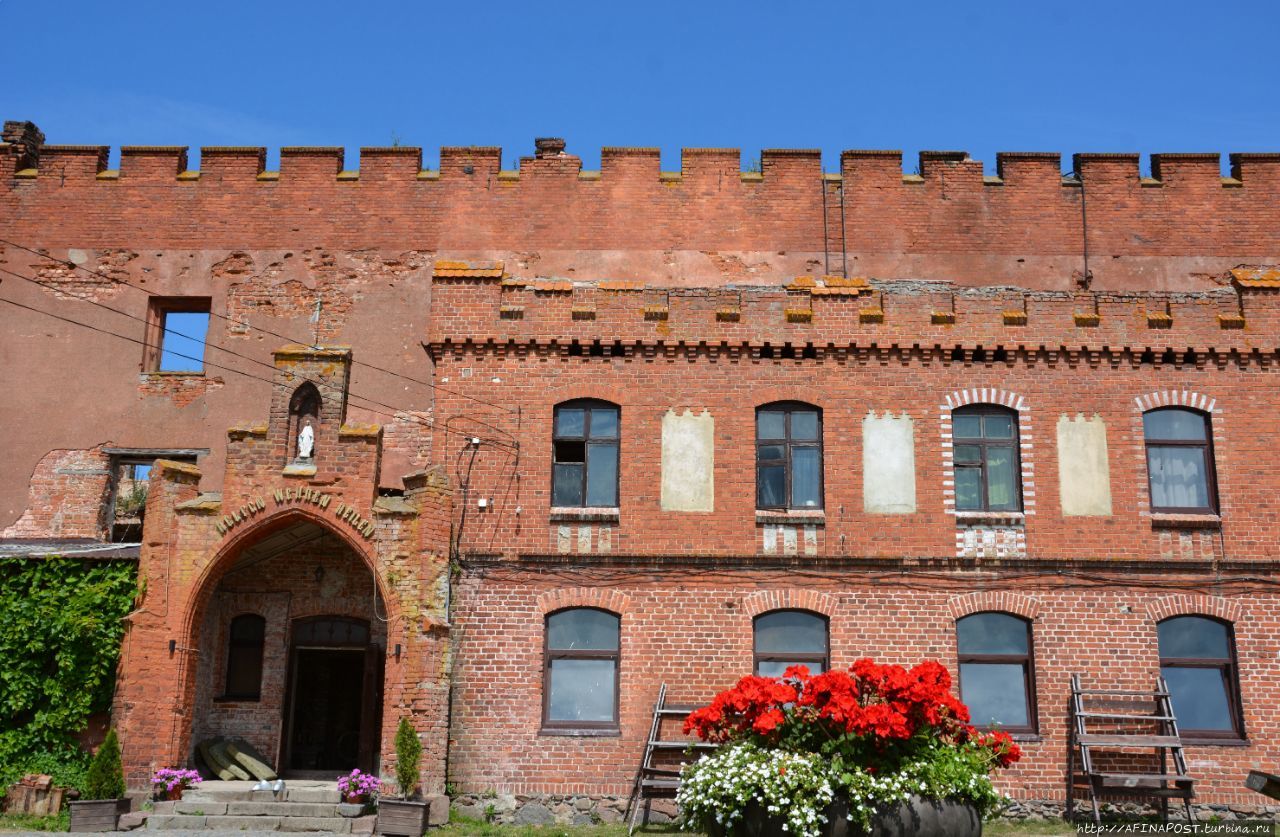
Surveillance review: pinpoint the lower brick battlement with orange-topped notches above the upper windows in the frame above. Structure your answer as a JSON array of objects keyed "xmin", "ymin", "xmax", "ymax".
[{"xmin": 429, "ymin": 272, "xmax": 1280, "ymax": 356}]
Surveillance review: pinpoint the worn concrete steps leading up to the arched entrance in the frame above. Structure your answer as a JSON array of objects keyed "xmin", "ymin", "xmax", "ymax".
[{"xmin": 146, "ymin": 779, "xmax": 375, "ymax": 834}]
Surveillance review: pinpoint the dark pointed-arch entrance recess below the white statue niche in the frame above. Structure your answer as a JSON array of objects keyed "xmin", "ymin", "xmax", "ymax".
[{"xmin": 191, "ymin": 516, "xmax": 388, "ymax": 779}]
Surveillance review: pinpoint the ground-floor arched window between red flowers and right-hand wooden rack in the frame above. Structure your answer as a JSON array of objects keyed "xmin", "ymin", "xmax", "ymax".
[{"xmin": 956, "ymin": 613, "xmax": 1036, "ymax": 732}]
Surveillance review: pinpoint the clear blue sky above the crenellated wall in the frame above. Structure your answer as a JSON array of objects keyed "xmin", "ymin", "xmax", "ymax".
[{"xmin": 0, "ymin": 0, "xmax": 1280, "ymax": 170}]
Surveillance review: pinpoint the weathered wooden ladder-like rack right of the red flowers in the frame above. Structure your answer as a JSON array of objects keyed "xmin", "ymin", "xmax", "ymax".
[{"xmin": 1066, "ymin": 674, "xmax": 1196, "ymax": 824}]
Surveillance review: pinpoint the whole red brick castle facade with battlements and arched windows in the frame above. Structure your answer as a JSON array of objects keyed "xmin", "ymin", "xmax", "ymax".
[{"xmin": 0, "ymin": 123, "xmax": 1280, "ymax": 811}]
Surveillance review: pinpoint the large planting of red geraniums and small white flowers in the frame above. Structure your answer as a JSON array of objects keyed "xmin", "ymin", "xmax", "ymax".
[{"xmin": 677, "ymin": 659, "xmax": 1021, "ymax": 837}]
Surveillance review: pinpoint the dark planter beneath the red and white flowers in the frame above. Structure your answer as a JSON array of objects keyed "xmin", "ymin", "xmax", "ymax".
[{"xmin": 713, "ymin": 796, "xmax": 982, "ymax": 837}]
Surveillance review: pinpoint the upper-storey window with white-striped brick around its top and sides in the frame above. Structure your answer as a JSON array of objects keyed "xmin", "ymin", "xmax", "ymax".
[{"xmin": 951, "ymin": 404, "xmax": 1023, "ymax": 512}]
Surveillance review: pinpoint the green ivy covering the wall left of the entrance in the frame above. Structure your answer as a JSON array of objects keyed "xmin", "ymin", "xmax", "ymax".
[{"xmin": 0, "ymin": 558, "xmax": 137, "ymax": 788}]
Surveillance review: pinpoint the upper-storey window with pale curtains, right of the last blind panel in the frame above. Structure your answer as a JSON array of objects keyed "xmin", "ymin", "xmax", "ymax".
[{"xmin": 1142, "ymin": 407, "xmax": 1217, "ymax": 514}]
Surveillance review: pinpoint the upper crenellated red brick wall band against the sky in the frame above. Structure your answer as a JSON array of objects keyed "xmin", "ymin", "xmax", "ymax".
[{"xmin": 0, "ymin": 123, "xmax": 1280, "ymax": 289}]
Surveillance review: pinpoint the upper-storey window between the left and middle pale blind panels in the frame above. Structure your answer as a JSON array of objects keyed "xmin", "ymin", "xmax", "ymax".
[{"xmin": 755, "ymin": 402, "xmax": 822, "ymax": 509}]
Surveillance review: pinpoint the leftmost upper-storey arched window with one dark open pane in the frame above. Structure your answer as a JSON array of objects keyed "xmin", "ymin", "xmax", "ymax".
[{"xmin": 552, "ymin": 399, "xmax": 618, "ymax": 508}]
